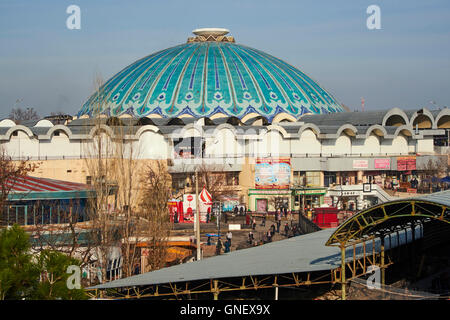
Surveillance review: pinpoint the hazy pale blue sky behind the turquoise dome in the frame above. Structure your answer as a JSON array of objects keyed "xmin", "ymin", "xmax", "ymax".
[{"xmin": 0, "ymin": 0, "xmax": 450, "ymax": 118}]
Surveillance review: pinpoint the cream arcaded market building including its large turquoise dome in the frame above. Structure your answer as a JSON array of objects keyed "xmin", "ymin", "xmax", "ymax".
[{"xmin": 0, "ymin": 29, "xmax": 450, "ymax": 212}]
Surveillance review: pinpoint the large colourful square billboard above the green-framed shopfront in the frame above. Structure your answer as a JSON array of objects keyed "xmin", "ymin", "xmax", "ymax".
[{"xmin": 255, "ymin": 158, "xmax": 291, "ymax": 189}]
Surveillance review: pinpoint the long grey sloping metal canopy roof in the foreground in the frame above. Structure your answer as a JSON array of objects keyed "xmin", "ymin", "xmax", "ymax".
[{"xmin": 90, "ymin": 229, "xmax": 340, "ymax": 289}]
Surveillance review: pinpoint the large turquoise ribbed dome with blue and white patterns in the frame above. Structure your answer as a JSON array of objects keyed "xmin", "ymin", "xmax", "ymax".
[{"xmin": 78, "ymin": 29, "xmax": 344, "ymax": 121}]
